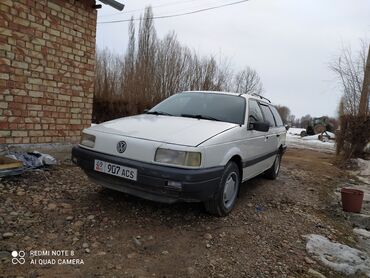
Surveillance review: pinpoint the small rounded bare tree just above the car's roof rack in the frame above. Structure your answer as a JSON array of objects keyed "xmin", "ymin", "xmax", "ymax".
[{"xmin": 234, "ymin": 67, "xmax": 263, "ymax": 95}]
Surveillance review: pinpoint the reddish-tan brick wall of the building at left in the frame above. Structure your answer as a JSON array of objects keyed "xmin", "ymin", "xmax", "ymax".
[{"xmin": 0, "ymin": 0, "xmax": 96, "ymax": 144}]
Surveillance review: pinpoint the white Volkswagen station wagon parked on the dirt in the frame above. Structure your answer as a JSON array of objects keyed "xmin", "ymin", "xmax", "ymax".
[{"xmin": 72, "ymin": 91, "xmax": 286, "ymax": 216}]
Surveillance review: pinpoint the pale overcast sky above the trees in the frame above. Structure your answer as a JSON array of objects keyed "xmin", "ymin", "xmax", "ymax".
[{"xmin": 97, "ymin": 0, "xmax": 370, "ymax": 117}]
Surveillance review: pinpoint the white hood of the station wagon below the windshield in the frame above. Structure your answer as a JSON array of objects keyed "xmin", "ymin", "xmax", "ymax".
[{"xmin": 89, "ymin": 114, "xmax": 238, "ymax": 147}]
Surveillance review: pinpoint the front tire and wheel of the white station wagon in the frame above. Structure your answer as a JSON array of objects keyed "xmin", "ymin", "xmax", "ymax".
[{"xmin": 204, "ymin": 161, "xmax": 241, "ymax": 216}]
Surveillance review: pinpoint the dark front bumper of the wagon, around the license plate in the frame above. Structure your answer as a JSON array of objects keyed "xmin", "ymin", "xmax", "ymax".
[{"xmin": 72, "ymin": 146, "xmax": 224, "ymax": 203}]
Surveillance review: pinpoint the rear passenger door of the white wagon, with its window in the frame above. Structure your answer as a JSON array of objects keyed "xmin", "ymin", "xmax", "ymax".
[{"xmin": 260, "ymin": 102, "xmax": 279, "ymax": 170}]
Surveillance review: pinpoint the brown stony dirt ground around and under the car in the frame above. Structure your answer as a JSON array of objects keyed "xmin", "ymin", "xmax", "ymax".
[{"xmin": 0, "ymin": 149, "xmax": 356, "ymax": 277}]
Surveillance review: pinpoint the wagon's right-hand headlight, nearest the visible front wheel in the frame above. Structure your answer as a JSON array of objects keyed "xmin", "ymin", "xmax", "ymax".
[{"xmin": 154, "ymin": 148, "xmax": 202, "ymax": 167}]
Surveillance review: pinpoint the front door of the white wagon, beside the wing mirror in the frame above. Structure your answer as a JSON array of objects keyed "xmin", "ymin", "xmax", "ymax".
[{"xmin": 243, "ymin": 99, "xmax": 272, "ymax": 180}]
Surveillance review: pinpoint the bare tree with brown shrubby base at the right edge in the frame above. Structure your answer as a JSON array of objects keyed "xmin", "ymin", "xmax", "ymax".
[{"xmin": 331, "ymin": 41, "xmax": 370, "ymax": 161}]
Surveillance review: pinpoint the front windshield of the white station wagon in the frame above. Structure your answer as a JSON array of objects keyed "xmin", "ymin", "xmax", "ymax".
[{"xmin": 148, "ymin": 92, "xmax": 245, "ymax": 124}]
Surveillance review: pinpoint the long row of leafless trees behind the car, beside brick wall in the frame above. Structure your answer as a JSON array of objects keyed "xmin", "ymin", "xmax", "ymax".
[{"xmin": 93, "ymin": 7, "xmax": 263, "ymax": 122}]
